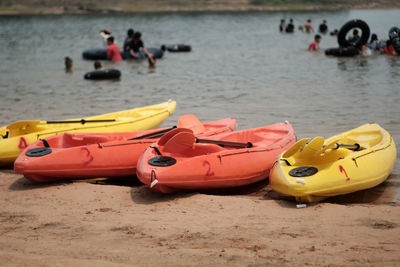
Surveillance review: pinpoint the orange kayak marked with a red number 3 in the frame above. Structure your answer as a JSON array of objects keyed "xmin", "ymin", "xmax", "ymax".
[{"xmin": 14, "ymin": 115, "xmax": 236, "ymax": 182}]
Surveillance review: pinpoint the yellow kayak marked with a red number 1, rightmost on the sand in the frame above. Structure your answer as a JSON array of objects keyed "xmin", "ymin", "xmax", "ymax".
[{"xmin": 269, "ymin": 124, "xmax": 396, "ymax": 202}]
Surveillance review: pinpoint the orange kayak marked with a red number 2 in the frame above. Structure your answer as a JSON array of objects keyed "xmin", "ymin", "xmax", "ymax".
[{"xmin": 136, "ymin": 123, "xmax": 296, "ymax": 193}]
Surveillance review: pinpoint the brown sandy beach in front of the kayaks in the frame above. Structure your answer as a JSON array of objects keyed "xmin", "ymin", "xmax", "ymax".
[{"xmin": 0, "ymin": 170, "xmax": 400, "ymax": 266}]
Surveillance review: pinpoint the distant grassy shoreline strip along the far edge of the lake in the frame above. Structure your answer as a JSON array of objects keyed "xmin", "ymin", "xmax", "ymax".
[{"xmin": 0, "ymin": 1, "xmax": 400, "ymax": 15}]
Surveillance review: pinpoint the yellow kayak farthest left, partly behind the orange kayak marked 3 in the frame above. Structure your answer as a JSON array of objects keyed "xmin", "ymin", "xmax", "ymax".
[{"xmin": 0, "ymin": 101, "xmax": 176, "ymax": 167}]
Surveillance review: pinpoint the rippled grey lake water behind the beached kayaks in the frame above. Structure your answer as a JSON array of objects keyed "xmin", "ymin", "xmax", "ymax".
[{"xmin": 0, "ymin": 10, "xmax": 400, "ymax": 203}]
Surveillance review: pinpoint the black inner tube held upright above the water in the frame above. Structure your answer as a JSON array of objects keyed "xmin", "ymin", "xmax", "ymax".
[{"xmin": 338, "ymin": 19, "xmax": 370, "ymax": 48}]
